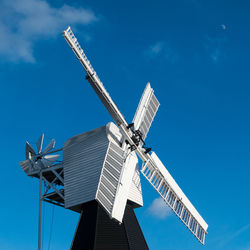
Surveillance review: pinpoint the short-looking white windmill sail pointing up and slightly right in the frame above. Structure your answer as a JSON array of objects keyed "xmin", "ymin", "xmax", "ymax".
[{"xmin": 133, "ymin": 83, "xmax": 160, "ymax": 140}]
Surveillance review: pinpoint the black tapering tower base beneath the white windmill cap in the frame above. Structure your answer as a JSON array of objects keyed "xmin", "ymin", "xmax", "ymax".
[{"xmin": 71, "ymin": 201, "xmax": 149, "ymax": 250}]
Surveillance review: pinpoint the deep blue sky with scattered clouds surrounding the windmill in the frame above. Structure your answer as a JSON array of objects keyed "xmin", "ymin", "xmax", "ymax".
[{"xmin": 0, "ymin": 0, "xmax": 250, "ymax": 250}]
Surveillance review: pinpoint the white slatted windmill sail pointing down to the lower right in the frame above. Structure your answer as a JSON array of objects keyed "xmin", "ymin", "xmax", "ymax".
[{"xmin": 141, "ymin": 152, "xmax": 208, "ymax": 244}]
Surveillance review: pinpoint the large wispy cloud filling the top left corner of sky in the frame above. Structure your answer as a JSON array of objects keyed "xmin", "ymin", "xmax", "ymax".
[{"xmin": 0, "ymin": 0, "xmax": 97, "ymax": 62}]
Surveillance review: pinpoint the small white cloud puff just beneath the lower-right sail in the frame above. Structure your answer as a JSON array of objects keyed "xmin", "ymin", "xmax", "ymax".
[{"xmin": 148, "ymin": 197, "xmax": 172, "ymax": 219}]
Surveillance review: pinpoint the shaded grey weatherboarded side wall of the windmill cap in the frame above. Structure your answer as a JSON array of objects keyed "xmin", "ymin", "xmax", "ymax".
[{"xmin": 63, "ymin": 126, "xmax": 109, "ymax": 208}]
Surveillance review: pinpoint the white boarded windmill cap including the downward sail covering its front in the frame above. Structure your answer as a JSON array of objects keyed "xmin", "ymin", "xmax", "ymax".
[{"xmin": 63, "ymin": 122, "xmax": 143, "ymax": 223}]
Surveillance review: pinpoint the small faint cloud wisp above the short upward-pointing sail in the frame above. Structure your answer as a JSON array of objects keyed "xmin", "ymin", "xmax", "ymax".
[{"xmin": 145, "ymin": 41, "xmax": 179, "ymax": 63}]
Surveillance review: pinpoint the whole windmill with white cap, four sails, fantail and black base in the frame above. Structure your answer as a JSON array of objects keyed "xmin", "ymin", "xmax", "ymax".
[{"xmin": 20, "ymin": 27, "xmax": 208, "ymax": 250}]
